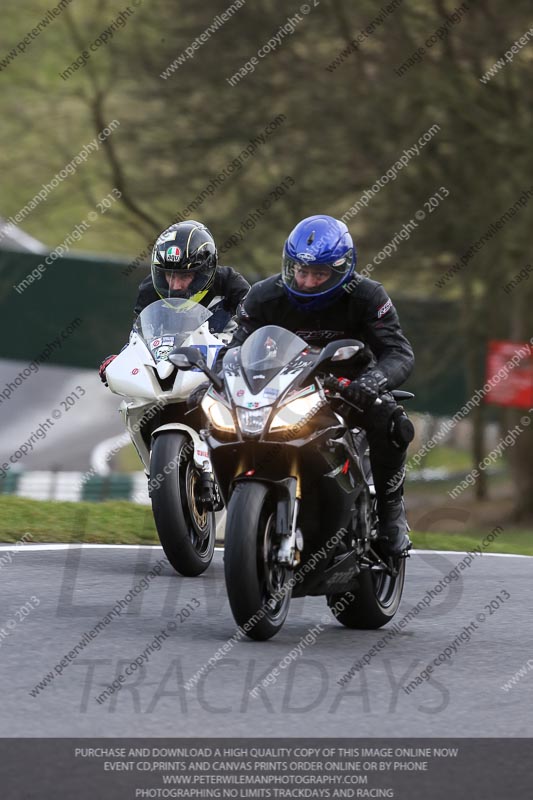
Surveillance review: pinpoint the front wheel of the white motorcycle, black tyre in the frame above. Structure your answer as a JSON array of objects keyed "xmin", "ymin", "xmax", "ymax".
[{"xmin": 150, "ymin": 431, "xmax": 216, "ymax": 577}]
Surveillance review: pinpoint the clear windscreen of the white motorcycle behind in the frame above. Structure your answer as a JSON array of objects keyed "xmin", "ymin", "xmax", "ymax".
[{"xmin": 133, "ymin": 298, "xmax": 212, "ymax": 361}]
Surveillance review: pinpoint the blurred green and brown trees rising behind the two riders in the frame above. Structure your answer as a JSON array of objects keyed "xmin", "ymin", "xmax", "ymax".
[{"xmin": 0, "ymin": 0, "xmax": 533, "ymax": 506}]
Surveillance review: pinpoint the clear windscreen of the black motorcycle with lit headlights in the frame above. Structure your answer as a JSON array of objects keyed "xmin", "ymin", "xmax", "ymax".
[{"xmin": 240, "ymin": 325, "xmax": 308, "ymax": 394}]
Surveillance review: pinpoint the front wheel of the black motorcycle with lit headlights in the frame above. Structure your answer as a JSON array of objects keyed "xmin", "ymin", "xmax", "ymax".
[{"xmin": 224, "ymin": 481, "xmax": 292, "ymax": 641}]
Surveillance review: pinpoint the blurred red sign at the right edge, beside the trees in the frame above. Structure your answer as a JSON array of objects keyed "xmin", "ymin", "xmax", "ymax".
[{"xmin": 485, "ymin": 341, "xmax": 533, "ymax": 408}]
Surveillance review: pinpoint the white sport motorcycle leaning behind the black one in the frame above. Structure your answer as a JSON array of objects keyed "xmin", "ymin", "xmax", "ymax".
[{"xmin": 106, "ymin": 299, "xmax": 231, "ymax": 576}]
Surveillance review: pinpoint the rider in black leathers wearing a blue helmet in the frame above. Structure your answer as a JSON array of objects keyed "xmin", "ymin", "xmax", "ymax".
[{"xmin": 230, "ymin": 216, "xmax": 414, "ymax": 556}]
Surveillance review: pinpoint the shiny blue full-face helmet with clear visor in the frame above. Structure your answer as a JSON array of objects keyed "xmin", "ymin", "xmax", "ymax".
[{"xmin": 281, "ymin": 214, "xmax": 357, "ymax": 311}]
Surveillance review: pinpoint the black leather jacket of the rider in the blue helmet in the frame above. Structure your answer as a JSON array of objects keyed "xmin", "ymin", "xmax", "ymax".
[{"xmin": 230, "ymin": 275, "xmax": 414, "ymax": 389}]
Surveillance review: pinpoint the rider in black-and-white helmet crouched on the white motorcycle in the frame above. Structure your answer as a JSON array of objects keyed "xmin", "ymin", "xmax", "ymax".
[{"xmin": 99, "ymin": 220, "xmax": 250, "ymax": 385}]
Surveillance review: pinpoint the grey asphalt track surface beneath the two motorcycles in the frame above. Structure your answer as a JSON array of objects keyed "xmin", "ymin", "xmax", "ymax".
[{"xmin": 0, "ymin": 545, "xmax": 533, "ymax": 737}]
